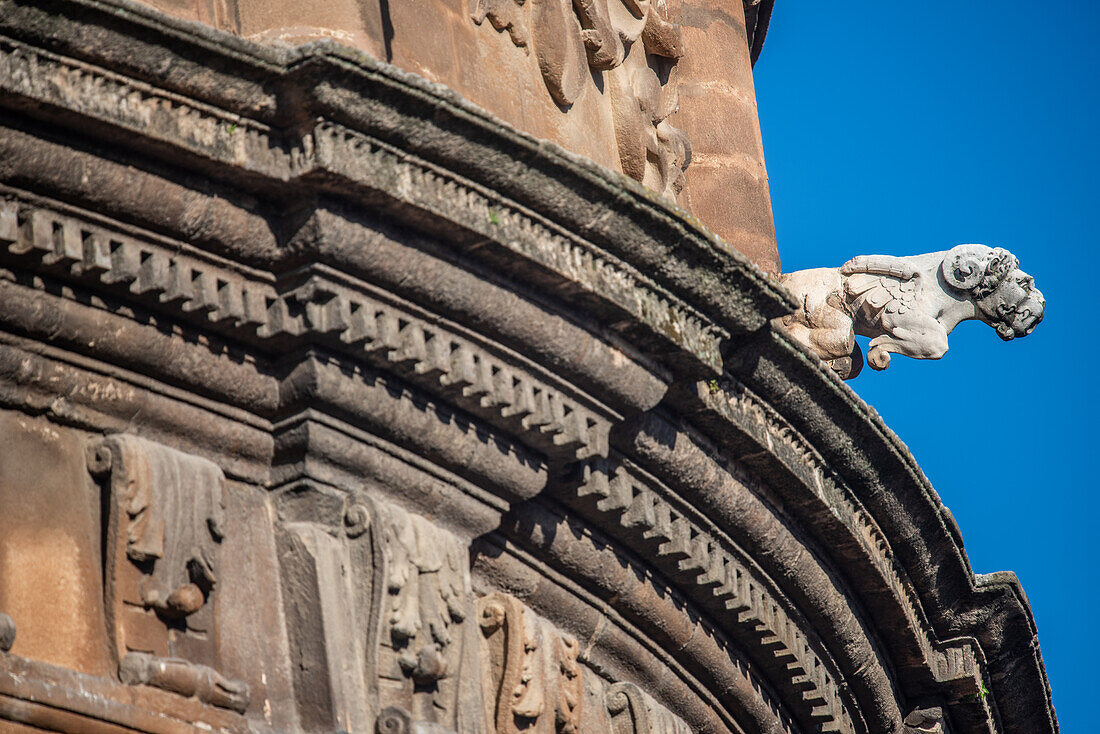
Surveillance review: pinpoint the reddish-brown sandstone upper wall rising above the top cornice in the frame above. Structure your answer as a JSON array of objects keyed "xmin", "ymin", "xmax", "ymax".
[{"xmin": 122, "ymin": 0, "xmax": 780, "ymax": 273}]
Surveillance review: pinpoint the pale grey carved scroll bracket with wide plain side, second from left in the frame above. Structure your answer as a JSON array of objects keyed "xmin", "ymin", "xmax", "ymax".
[{"xmin": 278, "ymin": 483, "xmax": 484, "ymax": 733}]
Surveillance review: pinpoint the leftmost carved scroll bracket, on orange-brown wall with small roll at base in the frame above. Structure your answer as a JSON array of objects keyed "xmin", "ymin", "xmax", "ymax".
[{"xmin": 88, "ymin": 435, "xmax": 249, "ymax": 711}]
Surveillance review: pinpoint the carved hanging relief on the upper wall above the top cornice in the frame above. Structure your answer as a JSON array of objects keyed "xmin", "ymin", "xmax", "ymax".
[{"xmin": 472, "ymin": 0, "xmax": 691, "ymax": 198}]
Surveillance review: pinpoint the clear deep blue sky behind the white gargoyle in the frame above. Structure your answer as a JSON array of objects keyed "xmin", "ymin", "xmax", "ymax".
[{"xmin": 755, "ymin": 0, "xmax": 1100, "ymax": 734}]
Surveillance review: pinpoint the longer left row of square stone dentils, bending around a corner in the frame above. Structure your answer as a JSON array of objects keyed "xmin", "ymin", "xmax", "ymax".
[{"xmin": 0, "ymin": 199, "xmax": 613, "ymax": 460}]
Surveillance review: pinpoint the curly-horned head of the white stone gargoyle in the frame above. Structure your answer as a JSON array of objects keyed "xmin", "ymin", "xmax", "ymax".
[{"xmin": 941, "ymin": 244, "xmax": 1046, "ymax": 341}]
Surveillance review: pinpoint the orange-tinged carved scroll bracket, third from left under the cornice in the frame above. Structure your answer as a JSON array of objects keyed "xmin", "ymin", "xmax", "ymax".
[{"xmin": 477, "ymin": 593, "xmax": 584, "ymax": 734}]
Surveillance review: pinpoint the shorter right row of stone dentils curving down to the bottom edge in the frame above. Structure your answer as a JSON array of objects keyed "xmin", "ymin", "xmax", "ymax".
[{"xmin": 565, "ymin": 458, "xmax": 856, "ymax": 734}]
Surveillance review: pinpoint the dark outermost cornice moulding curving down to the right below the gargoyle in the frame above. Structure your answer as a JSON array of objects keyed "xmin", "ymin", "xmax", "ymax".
[{"xmin": 727, "ymin": 328, "xmax": 1058, "ymax": 732}]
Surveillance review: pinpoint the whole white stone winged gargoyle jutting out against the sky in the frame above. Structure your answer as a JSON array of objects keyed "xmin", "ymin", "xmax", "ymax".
[{"xmin": 780, "ymin": 244, "xmax": 1046, "ymax": 380}]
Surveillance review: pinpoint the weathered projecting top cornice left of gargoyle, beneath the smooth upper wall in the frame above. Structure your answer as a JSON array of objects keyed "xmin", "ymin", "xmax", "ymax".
[{"xmin": 0, "ymin": 0, "xmax": 790, "ymax": 370}]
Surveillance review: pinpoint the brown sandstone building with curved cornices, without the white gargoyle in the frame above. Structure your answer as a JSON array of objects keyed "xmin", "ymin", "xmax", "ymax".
[{"xmin": 0, "ymin": 0, "xmax": 1058, "ymax": 734}]
